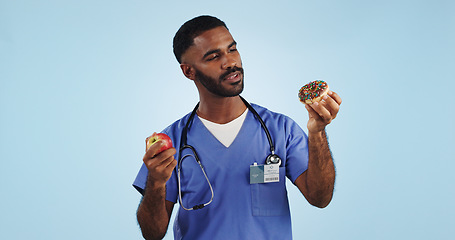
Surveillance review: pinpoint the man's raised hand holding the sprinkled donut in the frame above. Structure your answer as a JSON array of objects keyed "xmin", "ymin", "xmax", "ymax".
[{"xmin": 305, "ymin": 91, "xmax": 341, "ymax": 133}]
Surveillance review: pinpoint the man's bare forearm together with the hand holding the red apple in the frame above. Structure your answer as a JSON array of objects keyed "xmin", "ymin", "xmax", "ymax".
[{"xmin": 137, "ymin": 142, "xmax": 177, "ymax": 240}]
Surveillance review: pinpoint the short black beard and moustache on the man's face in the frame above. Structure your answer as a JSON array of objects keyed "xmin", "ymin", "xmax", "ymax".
[{"xmin": 195, "ymin": 67, "xmax": 243, "ymax": 97}]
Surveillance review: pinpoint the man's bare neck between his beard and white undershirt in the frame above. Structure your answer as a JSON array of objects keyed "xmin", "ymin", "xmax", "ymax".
[{"xmin": 197, "ymin": 96, "xmax": 246, "ymax": 124}]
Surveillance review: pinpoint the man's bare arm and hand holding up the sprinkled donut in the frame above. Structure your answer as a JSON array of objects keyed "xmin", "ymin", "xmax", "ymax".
[{"xmin": 295, "ymin": 91, "xmax": 341, "ymax": 208}]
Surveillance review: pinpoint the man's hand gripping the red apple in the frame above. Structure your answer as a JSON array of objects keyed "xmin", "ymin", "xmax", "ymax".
[{"xmin": 142, "ymin": 138, "xmax": 177, "ymax": 188}]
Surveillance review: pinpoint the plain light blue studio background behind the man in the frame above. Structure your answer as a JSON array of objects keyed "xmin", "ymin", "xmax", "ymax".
[{"xmin": 0, "ymin": 0, "xmax": 455, "ymax": 240}]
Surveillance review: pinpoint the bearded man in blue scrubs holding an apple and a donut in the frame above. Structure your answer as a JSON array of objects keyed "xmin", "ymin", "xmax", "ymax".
[{"xmin": 133, "ymin": 16, "xmax": 341, "ymax": 239}]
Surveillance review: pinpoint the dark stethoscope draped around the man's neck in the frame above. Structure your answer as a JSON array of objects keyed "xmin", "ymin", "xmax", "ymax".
[{"xmin": 177, "ymin": 96, "xmax": 281, "ymax": 211}]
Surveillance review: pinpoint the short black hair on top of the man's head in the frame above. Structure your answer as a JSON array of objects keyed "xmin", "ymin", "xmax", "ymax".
[{"xmin": 173, "ymin": 15, "xmax": 229, "ymax": 63}]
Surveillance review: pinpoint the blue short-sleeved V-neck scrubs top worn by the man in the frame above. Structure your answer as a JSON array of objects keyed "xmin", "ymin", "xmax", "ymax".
[{"xmin": 133, "ymin": 104, "xmax": 308, "ymax": 240}]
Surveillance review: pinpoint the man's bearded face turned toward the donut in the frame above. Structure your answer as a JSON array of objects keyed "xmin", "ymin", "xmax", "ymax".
[{"xmin": 182, "ymin": 27, "xmax": 244, "ymax": 97}]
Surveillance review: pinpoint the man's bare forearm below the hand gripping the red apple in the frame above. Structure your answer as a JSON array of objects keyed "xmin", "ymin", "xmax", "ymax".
[{"xmin": 137, "ymin": 181, "xmax": 169, "ymax": 240}]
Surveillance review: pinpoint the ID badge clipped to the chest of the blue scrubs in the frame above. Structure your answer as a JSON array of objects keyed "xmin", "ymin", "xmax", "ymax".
[{"xmin": 250, "ymin": 163, "xmax": 280, "ymax": 184}]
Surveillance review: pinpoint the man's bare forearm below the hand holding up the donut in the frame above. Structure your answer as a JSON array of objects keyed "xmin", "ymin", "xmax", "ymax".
[{"xmin": 306, "ymin": 131, "xmax": 335, "ymax": 207}]
